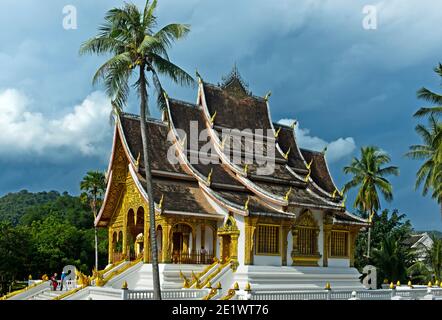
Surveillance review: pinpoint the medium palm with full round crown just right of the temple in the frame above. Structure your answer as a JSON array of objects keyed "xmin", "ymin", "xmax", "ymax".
[{"xmin": 344, "ymin": 146, "xmax": 399, "ymax": 258}]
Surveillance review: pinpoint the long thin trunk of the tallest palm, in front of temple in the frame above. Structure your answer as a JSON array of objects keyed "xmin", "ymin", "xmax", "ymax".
[{"xmin": 140, "ymin": 64, "xmax": 161, "ymax": 300}]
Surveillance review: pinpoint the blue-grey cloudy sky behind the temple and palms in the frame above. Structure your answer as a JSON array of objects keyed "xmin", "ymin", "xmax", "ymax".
[{"xmin": 0, "ymin": 0, "xmax": 442, "ymax": 230}]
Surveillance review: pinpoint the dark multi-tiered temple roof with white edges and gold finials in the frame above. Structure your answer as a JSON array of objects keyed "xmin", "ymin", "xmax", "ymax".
[{"xmin": 96, "ymin": 68, "xmax": 365, "ymax": 226}]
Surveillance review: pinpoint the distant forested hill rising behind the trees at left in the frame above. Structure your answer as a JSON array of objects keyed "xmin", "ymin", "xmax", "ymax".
[{"xmin": 0, "ymin": 190, "xmax": 92, "ymax": 228}]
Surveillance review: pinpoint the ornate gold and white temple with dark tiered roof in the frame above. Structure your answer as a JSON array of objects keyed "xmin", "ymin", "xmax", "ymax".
[{"xmin": 95, "ymin": 69, "xmax": 367, "ymax": 287}]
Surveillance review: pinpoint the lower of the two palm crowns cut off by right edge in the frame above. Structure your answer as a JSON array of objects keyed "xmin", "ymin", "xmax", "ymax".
[{"xmin": 405, "ymin": 115, "xmax": 442, "ymax": 214}]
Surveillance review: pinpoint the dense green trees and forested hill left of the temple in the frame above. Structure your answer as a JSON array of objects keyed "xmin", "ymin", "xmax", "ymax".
[{"xmin": 0, "ymin": 190, "xmax": 107, "ymax": 296}]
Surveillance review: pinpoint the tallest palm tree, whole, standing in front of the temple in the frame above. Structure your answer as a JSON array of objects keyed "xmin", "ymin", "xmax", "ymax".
[{"xmin": 80, "ymin": 0, "xmax": 194, "ymax": 299}]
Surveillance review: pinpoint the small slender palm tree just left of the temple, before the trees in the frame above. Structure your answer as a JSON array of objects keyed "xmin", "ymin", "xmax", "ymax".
[{"xmin": 80, "ymin": 171, "xmax": 106, "ymax": 271}]
